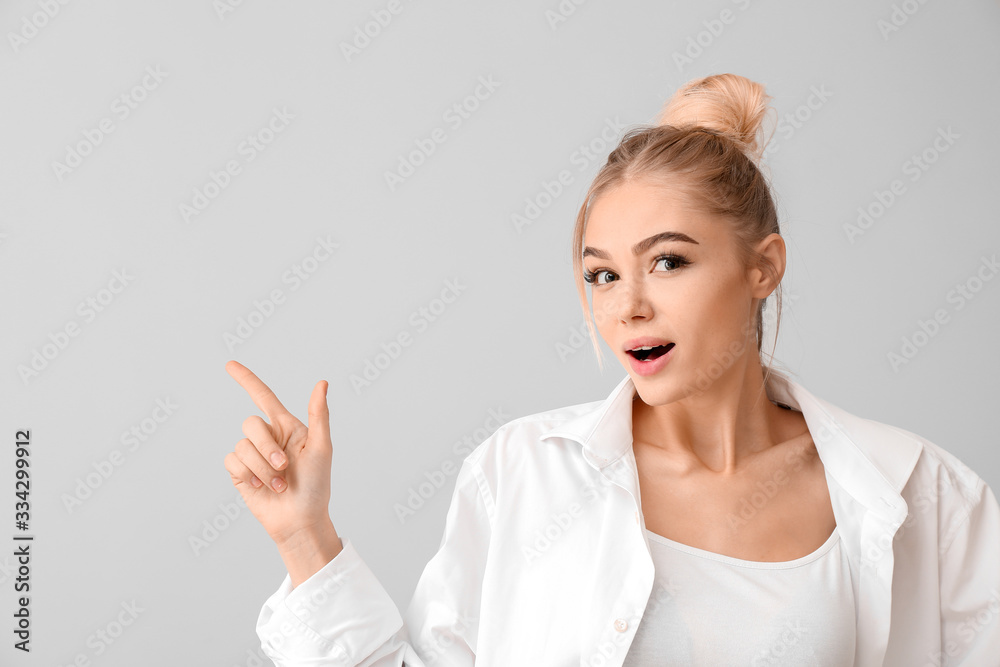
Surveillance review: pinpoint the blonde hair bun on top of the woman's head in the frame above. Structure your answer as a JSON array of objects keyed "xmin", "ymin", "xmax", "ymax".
[{"xmin": 657, "ymin": 74, "xmax": 773, "ymax": 165}]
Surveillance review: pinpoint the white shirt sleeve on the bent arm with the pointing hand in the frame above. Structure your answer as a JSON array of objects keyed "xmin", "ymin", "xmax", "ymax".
[{"xmin": 257, "ymin": 450, "xmax": 493, "ymax": 667}]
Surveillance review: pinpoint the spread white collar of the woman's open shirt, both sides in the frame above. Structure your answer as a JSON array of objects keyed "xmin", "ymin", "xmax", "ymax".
[{"xmin": 541, "ymin": 369, "xmax": 923, "ymax": 524}]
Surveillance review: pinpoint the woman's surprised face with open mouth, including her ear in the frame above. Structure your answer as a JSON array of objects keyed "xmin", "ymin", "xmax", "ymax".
[{"xmin": 583, "ymin": 177, "xmax": 783, "ymax": 405}]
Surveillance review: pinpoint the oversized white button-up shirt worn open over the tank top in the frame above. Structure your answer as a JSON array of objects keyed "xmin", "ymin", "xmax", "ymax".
[{"xmin": 257, "ymin": 371, "xmax": 1000, "ymax": 667}]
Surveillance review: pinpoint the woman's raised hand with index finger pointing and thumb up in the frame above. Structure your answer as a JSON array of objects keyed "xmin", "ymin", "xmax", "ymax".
[{"xmin": 225, "ymin": 360, "xmax": 339, "ymax": 556}]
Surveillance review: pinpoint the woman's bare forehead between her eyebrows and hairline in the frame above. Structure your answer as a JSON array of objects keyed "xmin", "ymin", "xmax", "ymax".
[{"xmin": 583, "ymin": 180, "xmax": 724, "ymax": 249}]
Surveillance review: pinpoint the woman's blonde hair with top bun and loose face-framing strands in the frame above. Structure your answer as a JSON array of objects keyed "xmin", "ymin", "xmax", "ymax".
[{"xmin": 573, "ymin": 74, "xmax": 781, "ymax": 383}]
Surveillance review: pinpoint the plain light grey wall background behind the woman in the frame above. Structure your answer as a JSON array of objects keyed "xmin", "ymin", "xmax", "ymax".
[{"xmin": 0, "ymin": 0, "xmax": 1000, "ymax": 667}]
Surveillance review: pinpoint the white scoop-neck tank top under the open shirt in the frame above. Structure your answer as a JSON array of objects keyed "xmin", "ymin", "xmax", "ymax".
[{"xmin": 623, "ymin": 529, "xmax": 856, "ymax": 667}]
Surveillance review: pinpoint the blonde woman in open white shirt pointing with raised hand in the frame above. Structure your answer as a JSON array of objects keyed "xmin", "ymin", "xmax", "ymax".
[{"xmin": 225, "ymin": 74, "xmax": 1000, "ymax": 667}]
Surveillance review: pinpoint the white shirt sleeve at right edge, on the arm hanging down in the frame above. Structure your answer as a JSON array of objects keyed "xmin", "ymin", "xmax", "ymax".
[{"xmin": 940, "ymin": 480, "xmax": 1000, "ymax": 667}]
